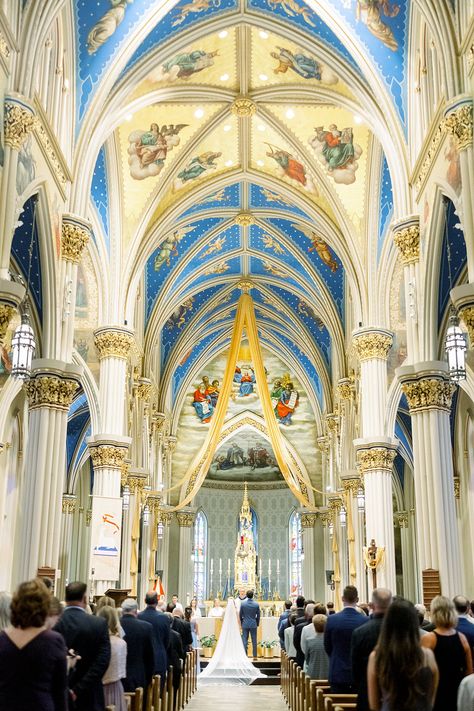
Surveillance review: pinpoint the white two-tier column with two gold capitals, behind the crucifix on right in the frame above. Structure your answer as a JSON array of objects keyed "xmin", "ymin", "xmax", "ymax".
[{"xmin": 353, "ymin": 328, "xmax": 396, "ymax": 593}]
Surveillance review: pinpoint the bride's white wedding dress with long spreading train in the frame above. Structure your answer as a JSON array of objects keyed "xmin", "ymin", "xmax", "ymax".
[{"xmin": 198, "ymin": 598, "xmax": 265, "ymax": 686}]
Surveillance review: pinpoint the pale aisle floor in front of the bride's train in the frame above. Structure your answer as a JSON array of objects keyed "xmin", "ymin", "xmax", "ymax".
[{"xmin": 186, "ymin": 685, "xmax": 288, "ymax": 711}]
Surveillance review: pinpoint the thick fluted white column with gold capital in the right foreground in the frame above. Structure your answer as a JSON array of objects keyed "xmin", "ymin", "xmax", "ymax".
[{"xmin": 396, "ymin": 361, "xmax": 463, "ymax": 597}]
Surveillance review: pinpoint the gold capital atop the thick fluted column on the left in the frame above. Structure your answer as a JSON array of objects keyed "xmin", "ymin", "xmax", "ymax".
[{"xmin": 23, "ymin": 359, "xmax": 82, "ymax": 411}]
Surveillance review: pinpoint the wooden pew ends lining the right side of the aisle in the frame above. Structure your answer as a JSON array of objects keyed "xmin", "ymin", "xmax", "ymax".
[{"xmin": 280, "ymin": 650, "xmax": 357, "ymax": 711}]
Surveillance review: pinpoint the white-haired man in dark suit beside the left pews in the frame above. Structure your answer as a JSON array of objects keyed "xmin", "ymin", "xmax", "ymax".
[{"xmin": 120, "ymin": 597, "xmax": 154, "ymax": 696}]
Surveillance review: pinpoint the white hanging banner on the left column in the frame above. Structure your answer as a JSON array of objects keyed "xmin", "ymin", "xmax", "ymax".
[{"xmin": 91, "ymin": 496, "xmax": 122, "ymax": 580}]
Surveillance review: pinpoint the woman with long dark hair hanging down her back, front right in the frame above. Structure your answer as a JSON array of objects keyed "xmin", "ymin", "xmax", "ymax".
[{"xmin": 367, "ymin": 599, "xmax": 438, "ymax": 711}]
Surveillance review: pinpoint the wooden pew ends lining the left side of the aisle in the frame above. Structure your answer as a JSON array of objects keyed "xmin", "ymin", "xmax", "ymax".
[{"xmin": 106, "ymin": 649, "xmax": 198, "ymax": 711}]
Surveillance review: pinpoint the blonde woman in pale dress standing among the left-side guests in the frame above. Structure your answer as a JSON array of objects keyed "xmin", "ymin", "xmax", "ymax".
[{"xmin": 97, "ymin": 605, "xmax": 127, "ymax": 711}]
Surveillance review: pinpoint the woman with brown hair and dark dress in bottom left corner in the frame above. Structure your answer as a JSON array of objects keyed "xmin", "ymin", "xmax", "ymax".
[{"xmin": 0, "ymin": 580, "xmax": 67, "ymax": 711}]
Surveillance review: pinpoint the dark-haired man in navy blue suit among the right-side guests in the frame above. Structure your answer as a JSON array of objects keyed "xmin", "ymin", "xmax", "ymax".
[{"xmin": 324, "ymin": 585, "xmax": 368, "ymax": 694}]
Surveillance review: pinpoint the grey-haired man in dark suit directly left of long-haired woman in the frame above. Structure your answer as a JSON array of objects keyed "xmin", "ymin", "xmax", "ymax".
[{"xmin": 351, "ymin": 588, "xmax": 390, "ymax": 711}]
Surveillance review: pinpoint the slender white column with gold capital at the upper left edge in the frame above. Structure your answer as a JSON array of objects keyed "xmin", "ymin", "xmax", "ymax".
[{"xmin": 0, "ymin": 93, "xmax": 36, "ymax": 280}]
